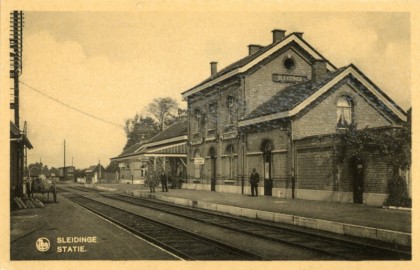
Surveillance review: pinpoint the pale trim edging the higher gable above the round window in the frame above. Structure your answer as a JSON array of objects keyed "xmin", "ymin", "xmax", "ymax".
[{"xmin": 181, "ymin": 33, "xmax": 336, "ymax": 100}]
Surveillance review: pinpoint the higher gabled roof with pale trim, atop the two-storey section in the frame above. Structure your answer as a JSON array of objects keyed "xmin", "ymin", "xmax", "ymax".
[{"xmin": 182, "ymin": 33, "xmax": 336, "ymax": 98}]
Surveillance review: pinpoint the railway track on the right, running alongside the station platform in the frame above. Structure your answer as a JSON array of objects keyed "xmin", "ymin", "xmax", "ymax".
[{"xmin": 103, "ymin": 194, "xmax": 411, "ymax": 260}]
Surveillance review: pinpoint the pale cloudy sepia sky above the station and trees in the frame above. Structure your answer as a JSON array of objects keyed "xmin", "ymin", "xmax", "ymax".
[{"xmin": 13, "ymin": 9, "xmax": 411, "ymax": 168}]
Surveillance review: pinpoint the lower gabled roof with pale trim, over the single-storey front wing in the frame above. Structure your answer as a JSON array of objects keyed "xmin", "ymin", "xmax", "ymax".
[{"xmin": 239, "ymin": 64, "xmax": 407, "ymax": 126}]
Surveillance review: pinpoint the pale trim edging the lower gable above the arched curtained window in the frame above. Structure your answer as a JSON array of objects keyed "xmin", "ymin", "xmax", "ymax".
[{"xmin": 238, "ymin": 66, "xmax": 407, "ymax": 127}]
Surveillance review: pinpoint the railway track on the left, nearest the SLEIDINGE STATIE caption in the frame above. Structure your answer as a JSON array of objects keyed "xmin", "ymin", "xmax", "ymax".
[{"xmin": 61, "ymin": 189, "xmax": 267, "ymax": 260}]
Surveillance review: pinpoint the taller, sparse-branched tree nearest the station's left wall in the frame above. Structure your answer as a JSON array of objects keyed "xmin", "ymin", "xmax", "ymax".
[{"xmin": 147, "ymin": 97, "xmax": 178, "ymax": 131}]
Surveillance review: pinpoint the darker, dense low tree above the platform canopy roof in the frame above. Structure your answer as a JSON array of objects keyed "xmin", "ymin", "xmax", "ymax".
[{"xmin": 123, "ymin": 113, "xmax": 159, "ymax": 150}]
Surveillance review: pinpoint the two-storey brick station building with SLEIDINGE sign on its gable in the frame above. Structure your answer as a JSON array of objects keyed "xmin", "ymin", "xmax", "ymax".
[{"xmin": 182, "ymin": 30, "xmax": 407, "ymax": 205}]
